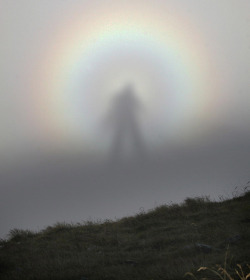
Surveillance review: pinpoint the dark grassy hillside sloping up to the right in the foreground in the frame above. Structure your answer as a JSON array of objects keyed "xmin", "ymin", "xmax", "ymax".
[{"xmin": 0, "ymin": 189, "xmax": 250, "ymax": 280}]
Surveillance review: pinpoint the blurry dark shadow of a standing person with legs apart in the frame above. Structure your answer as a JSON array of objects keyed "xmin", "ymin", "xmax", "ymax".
[{"xmin": 106, "ymin": 85, "xmax": 145, "ymax": 160}]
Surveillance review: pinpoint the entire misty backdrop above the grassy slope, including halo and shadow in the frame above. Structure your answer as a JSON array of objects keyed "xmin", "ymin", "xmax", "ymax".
[{"xmin": 0, "ymin": 0, "xmax": 250, "ymax": 236}]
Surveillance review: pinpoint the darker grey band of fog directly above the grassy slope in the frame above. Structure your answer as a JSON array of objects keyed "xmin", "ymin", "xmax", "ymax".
[{"xmin": 0, "ymin": 126, "xmax": 250, "ymax": 236}]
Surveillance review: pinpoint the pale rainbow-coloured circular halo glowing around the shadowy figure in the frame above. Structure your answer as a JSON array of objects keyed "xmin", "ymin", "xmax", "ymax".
[{"xmin": 28, "ymin": 2, "xmax": 216, "ymax": 154}]
